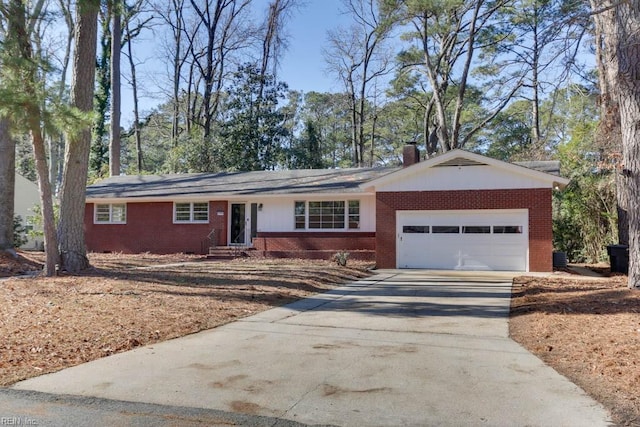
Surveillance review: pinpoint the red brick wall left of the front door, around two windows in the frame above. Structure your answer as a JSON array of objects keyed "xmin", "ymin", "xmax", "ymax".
[{"xmin": 84, "ymin": 201, "xmax": 227, "ymax": 254}]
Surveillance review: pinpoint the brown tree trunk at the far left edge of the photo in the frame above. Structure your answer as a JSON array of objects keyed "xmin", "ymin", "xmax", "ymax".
[{"xmin": 0, "ymin": 118, "xmax": 16, "ymax": 251}]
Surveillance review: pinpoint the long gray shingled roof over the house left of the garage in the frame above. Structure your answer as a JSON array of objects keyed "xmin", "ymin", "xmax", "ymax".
[{"xmin": 86, "ymin": 168, "xmax": 397, "ymax": 199}]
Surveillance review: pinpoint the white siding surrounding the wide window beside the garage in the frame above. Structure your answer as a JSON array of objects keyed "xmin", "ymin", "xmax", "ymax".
[{"xmin": 256, "ymin": 193, "xmax": 376, "ymax": 232}]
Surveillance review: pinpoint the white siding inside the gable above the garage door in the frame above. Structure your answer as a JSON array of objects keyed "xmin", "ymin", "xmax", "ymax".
[{"xmin": 376, "ymin": 166, "xmax": 549, "ymax": 191}]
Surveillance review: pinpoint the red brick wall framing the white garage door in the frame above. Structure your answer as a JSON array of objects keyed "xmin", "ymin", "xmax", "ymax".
[{"xmin": 376, "ymin": 188, "xmax": 553, "ymax": 271}]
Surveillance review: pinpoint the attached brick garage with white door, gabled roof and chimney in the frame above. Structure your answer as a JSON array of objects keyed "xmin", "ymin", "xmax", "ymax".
[{"xmin": 361, "ymin": 149, "xmax": 569, "ymax": 271}]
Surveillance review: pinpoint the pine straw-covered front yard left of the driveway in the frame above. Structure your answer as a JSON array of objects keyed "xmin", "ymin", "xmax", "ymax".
[{"xmin": 0, "ymin": 253, "xmax": 370, "ymax": 386}]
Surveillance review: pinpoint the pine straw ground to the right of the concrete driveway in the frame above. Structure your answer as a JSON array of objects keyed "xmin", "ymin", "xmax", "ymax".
[{"xmin": 509, "ymin": 276, "xmax": 640, "ymax": 426}]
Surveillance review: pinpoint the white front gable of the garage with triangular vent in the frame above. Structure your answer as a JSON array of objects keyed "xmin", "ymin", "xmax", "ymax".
[{"xmin": 362, "ymin": 149, "xmax": 569, "ymax": 191}]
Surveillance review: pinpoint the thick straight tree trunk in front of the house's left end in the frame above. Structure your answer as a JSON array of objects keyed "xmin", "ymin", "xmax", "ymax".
[{"xmin": 58, "ymin": 0, "xmax": 100, "ymax": 273}]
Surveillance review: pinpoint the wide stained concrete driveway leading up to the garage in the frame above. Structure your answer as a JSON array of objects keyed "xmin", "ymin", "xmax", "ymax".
[{"xmin": 13, "ymin": 270, "xmax": 608, "ymax": 426}]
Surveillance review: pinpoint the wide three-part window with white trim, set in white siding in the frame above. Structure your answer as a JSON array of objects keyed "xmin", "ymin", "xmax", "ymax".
[{"xmin": 293, "ymin": 200, "xmax": 360, "ymax": 230}]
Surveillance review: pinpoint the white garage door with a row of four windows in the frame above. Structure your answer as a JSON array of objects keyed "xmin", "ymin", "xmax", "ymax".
[{"xmin": 396, "ymin": 210, "xmax": 529, "ymax": 271}]
